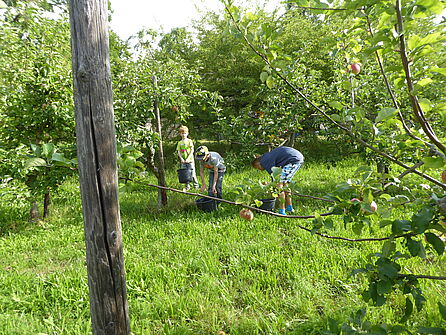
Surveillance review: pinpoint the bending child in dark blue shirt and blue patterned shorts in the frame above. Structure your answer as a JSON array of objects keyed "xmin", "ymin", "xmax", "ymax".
[{"xmin": 251, "ymin": 147, "xmax": 304, "ymax": 215}]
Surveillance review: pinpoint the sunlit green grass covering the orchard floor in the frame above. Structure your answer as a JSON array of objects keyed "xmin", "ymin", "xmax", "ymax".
[{"xmin": 0, "ymin": 158, "xmax": 446, "ymax": 335}]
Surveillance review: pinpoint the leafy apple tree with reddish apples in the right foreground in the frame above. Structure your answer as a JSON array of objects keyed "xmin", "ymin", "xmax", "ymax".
[{"xmin": 221, "ymin": 0, "xmax": 446, "ymax": 334}]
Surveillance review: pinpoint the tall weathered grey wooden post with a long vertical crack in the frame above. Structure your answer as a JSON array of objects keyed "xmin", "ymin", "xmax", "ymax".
[{"xmin": 70, "ymin": 0, "xmax": 130, "ymax": 335}]
